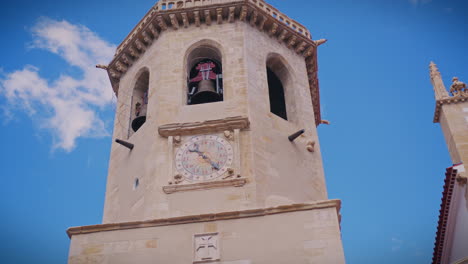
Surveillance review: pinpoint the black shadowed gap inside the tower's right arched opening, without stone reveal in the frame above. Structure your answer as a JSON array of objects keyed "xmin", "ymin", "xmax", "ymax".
[{"xmin": 267, "ymin": 67, "xmax": 288, "ymax": 120}]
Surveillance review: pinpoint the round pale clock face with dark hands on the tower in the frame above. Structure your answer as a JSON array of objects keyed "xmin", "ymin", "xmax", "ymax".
[{"xmin": 175, "ymin": 135, "xmax": 234, "ymax": 182}]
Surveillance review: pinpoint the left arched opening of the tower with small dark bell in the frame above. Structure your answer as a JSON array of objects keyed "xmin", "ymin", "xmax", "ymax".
[{"xmin": 130, "ymin": 70, "xmax": 149, "ymax": 135}]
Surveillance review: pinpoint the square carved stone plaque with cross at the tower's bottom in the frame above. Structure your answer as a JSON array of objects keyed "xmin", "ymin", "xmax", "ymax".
[{"xmin": 193, "ymin": 233, "xmax": 220, "ymax": 263}]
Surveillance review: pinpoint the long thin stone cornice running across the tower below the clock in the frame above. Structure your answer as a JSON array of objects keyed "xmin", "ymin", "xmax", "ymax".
[{"xmin": 67, "ymin": 200, "xmax": 341, "ymax": 238}]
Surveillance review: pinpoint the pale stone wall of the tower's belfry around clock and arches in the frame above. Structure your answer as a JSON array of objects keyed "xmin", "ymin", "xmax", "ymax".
[{"xmin": 103, "ymin": 21, "xmax": 327, "ymax": 223}]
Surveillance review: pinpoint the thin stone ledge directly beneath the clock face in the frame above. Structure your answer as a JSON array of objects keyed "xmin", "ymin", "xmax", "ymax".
[{"xmin": 163, "ymin": 178, "xmax": 247, "ymax": 194}]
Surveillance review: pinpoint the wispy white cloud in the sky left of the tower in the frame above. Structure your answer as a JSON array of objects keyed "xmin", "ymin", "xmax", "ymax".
[{"xmin": 0, "ymin": 18, "xmax": 115, "ymax": 151}]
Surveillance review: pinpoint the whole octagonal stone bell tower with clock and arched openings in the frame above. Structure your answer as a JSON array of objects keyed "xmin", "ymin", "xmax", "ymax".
[{"xmin": 67, "ymin": 0, "xmax": 344, "ymax": 264}]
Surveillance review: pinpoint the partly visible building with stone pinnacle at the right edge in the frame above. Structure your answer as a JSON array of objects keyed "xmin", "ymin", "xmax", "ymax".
[{"xmin": 429, "ymin": 62, "xmax": 468, "ymax": 264}]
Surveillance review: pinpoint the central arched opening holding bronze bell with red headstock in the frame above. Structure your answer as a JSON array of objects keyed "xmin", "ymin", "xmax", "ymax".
[{"xmin": 187, "ymin": 45, "xmax": 223, "ymax": 105}]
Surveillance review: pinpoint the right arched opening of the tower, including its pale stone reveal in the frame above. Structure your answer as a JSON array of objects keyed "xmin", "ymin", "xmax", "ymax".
[{"xmin": 266, "ymin": 56, "xmax": 289, "ymax": 120}]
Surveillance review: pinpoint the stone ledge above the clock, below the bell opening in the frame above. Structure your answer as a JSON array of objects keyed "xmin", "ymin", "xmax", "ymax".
[{"xmin": 158, "ymin": 116, "xmax": 250, "ymax": 137}]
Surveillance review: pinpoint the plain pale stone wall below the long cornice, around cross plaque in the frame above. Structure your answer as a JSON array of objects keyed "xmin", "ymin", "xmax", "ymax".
[{"xmin": 69, "ymin": 208, "xmax": 344, "ymax": 264}]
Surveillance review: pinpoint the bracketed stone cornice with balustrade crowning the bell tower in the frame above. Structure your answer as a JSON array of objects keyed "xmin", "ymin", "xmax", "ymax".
[{"xmin": 107, "ymin": 0, "xmax": 321, "ymax": 126}]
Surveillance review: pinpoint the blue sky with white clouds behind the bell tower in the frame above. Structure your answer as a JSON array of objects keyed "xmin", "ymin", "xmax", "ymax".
[{"xmin": 0, "ymin": 0, "xmax": 468, "ymax": 264}]
